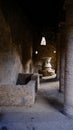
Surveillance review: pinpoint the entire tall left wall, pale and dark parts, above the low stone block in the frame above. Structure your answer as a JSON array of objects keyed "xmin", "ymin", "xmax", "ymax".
[{"xmin": 0, "ymin": 1, "xmax": 32, "ymax": 85}]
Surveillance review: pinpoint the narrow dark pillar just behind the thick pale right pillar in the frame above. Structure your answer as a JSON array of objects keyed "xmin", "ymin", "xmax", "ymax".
[{"xmin": 59, "ymin": 23, "xmax": 65, "ymax": 92}]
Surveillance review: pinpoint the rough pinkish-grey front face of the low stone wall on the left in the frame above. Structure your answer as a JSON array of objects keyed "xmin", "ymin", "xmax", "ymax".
[{"xmin": 0, "ymin": 80, "xmax": 36, "ymax": 106}]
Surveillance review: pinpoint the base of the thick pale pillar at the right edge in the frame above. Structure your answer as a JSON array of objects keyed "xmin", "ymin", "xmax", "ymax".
[{"xmin": 63, "ymin": 105, "xmax": 73, "ymax": 118}]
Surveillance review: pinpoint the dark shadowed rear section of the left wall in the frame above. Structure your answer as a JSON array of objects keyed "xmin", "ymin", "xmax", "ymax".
[{"xmin": 0, "ymin": 0, "xmax": 32, "ymax": 73}]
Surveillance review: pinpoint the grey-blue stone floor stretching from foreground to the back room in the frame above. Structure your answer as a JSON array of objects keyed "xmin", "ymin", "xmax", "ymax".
[{"xmin": 0, "ymin": 80, "xmax": 73, "ymax": 130}]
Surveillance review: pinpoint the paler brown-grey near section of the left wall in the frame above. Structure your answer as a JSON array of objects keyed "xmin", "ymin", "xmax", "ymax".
[{"xmin": 0, "ymin": 10, "xmax": 22, "ymax": 85}]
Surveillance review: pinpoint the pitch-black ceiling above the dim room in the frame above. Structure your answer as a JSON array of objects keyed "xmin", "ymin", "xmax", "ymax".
[{"xmin": 20, "ymin": 0, "xmax": 64, "ymax": 27}]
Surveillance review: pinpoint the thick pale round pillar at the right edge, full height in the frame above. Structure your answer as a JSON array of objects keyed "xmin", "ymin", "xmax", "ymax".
[{"xmin": 64, "ymin": 0, "xmax": 73, "ymax": 117}]
